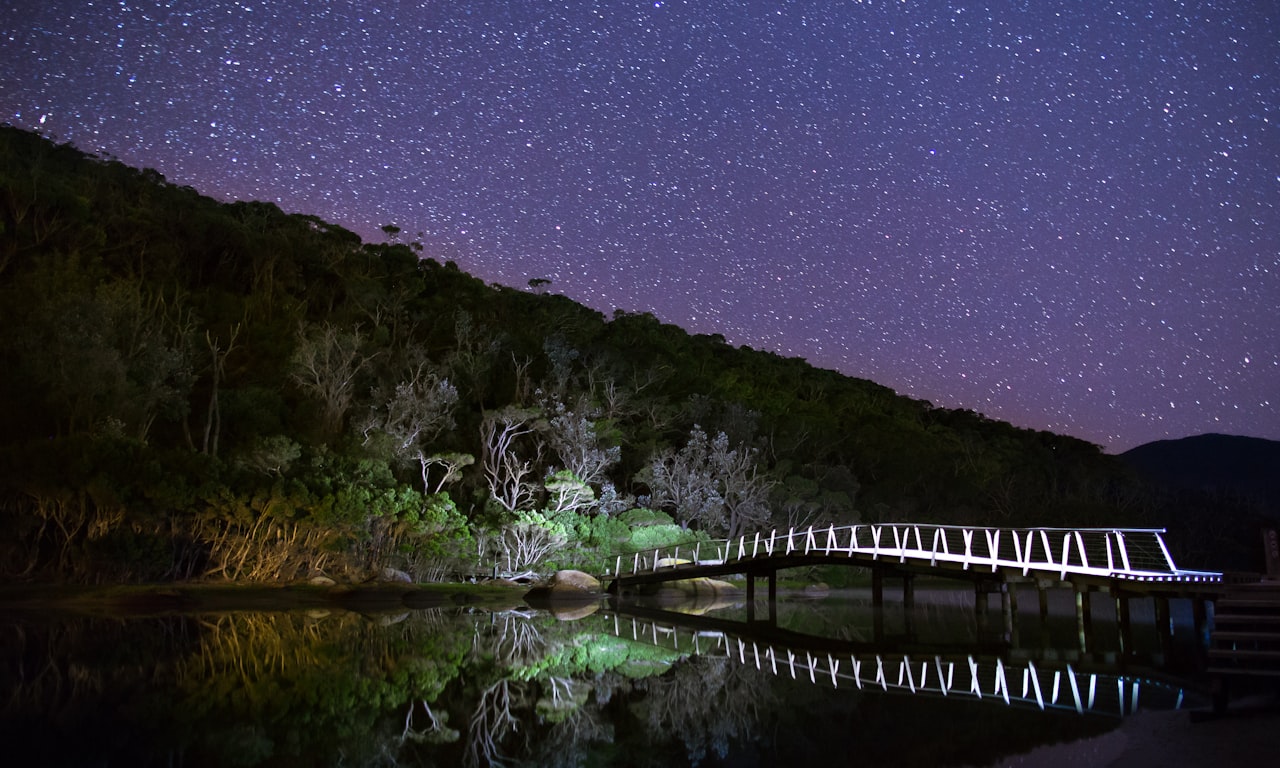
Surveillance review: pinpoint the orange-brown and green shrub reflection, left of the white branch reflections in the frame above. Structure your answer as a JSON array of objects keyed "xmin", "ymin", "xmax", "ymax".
[{"xmin": 178, "ymin": 612, "xmax": 467, "ymax": 758}]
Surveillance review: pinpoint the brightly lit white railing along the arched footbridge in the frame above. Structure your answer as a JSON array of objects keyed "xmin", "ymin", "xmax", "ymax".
[{"xmin": 611, "ymin": 522, "xmax": 1221, "ymax": 582}]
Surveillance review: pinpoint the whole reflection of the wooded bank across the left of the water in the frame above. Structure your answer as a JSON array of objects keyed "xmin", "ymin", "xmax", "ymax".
[{"xmin": 0, "ymin": 611, "xmax": 788, "ymax": 768}]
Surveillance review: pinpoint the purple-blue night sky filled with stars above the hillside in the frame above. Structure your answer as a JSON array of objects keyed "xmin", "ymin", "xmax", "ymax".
[{"xmin": 0, "ymin": 0, "xmax": 1280, "ymax": 452}]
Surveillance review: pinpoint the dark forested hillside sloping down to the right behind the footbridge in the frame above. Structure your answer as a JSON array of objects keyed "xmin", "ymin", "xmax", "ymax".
[{"xmin": 0, "ymin": 127, "xmax": 1244, "ymax": 581}]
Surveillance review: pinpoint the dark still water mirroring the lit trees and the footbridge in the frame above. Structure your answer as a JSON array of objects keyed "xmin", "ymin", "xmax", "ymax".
[{"xmin": 0, "ymin": 589, "xmax": 1203, "ymax": 765}]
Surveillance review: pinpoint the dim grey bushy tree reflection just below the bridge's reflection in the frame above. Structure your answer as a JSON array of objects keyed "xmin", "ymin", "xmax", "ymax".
[{"xmin": 635, "ymin": 657, "xmax": 777, "ymax": 764}]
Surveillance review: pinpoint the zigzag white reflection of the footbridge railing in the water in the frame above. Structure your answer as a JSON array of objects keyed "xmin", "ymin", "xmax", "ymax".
[{"xmin": 613, "ymin": 605, "xmax": 1185, "ymax": 717}]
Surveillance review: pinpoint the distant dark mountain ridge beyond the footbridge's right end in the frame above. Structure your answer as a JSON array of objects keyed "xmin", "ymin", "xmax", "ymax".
[{"xmin": 1120, "ymin": 434, "xmax": 1280, "ymax": 515}]
